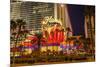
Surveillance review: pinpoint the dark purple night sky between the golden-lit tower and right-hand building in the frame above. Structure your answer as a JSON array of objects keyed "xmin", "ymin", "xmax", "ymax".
[{"xmin": 67, "ymin": 5, "xmax": 84, "ymax": 35}]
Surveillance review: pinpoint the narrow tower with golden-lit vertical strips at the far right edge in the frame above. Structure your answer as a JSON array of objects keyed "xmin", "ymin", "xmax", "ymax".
[{"xmin": 85, "ymin": 6, "xmax": 95, "ymax": 44}]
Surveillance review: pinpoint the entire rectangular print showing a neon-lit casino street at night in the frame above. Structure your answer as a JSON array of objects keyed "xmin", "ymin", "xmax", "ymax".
[{"xmin": 10, "ymin": 0, "xmax": 95, "ymax": 67}]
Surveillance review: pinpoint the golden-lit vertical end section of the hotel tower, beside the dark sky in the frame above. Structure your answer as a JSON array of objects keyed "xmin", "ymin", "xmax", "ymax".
[{"xmin": 55, "ymin": 4, "xmax": 72, "ymax": 30}]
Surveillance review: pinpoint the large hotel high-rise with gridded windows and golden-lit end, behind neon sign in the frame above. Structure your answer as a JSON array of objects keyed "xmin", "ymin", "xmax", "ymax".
[{"xmin": 11, "ymin": 1, "xmax": 72, "ymax": 30}]
